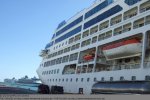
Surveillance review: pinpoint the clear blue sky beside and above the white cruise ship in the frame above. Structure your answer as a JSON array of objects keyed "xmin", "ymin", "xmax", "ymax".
[{"xmin": 0, "ymin": 0, "xmax": 94, "ymax": 81}]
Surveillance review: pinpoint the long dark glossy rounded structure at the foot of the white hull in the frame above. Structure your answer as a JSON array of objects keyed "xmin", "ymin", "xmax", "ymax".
[{"xmin": 92, "ymin": 81, "xmax": 150, "ymax": 94}]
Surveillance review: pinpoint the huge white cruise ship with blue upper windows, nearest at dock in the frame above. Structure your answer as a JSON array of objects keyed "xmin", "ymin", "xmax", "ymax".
[{"xmin": 37, "ymin": 0, "xmax": 150, "ymax": 94}]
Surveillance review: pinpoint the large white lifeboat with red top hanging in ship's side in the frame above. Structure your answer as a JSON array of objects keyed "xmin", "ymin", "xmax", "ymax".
[{"xmin": 102, "ymin": 39, "xmax": 142, "ymax": 60}]
